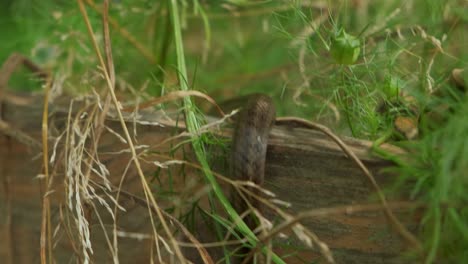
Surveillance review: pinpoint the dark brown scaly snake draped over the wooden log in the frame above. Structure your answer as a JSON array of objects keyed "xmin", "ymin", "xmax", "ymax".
[{"xmin": 231, "ymin": 94, "xmax": 276, "ymax": 262}]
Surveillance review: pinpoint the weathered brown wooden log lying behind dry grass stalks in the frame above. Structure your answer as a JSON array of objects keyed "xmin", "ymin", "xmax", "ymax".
[{"xmin": 0, "ymin": 92, "xmax": 414, "ymax": 263}]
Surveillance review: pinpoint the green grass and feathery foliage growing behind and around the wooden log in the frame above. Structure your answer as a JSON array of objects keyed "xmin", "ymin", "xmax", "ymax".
[{"xmin": 0, "ymin": 0, "xmax": 468, "ymax": 263}]
